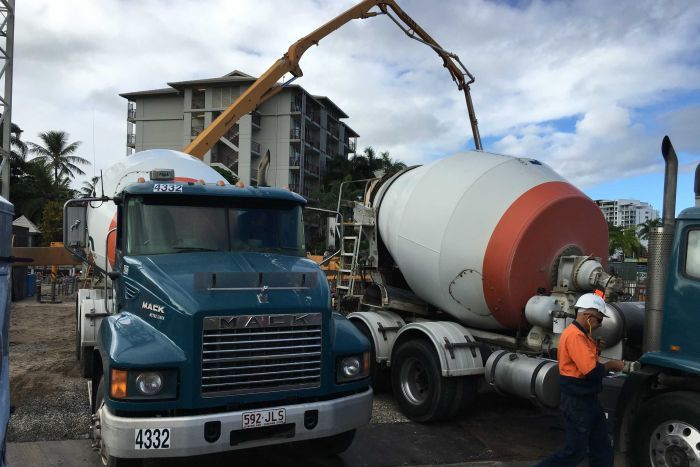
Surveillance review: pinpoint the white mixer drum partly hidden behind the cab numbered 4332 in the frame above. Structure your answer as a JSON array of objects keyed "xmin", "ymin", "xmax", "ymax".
[{"xmin": 87, "ymin": 149, "xmax": 228, "ymax": 269}]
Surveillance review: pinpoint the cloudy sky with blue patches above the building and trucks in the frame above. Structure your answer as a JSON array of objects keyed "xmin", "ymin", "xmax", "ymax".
[{"xmin": 13, "ymin": 0, "xmax": 700, "ymax": 212}]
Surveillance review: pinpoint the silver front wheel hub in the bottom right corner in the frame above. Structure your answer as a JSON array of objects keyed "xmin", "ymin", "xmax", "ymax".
[{"xmin": 649, "ymin": 420, "xmax": 700, "ymax": 467}]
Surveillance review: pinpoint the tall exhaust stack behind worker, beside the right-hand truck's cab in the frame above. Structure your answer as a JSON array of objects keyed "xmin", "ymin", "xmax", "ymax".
[{"xmin": 644, "ymin": 136, "xmax": 676, "ymax": 352}]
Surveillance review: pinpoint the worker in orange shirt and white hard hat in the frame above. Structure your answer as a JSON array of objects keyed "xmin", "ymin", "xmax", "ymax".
[{"xmin": 537, "ymin": 293, "xmax": 624, "ymax": 467}]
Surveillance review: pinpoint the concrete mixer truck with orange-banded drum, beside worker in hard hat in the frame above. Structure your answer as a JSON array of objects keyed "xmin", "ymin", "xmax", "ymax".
[{"xmin": 336, "ymin": 138, "xmax": 700, "ymax": 466}]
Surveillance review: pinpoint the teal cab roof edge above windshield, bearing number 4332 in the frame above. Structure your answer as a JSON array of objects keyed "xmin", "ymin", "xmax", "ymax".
[{"xmin": 124, "ymin": 180, "xmax": 306, "ymax": 204}]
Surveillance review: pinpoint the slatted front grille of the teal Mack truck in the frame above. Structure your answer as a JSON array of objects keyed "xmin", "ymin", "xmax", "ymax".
[{"xmin": 202, "ymin": 313, "xmax": 322, "ymax": 397}]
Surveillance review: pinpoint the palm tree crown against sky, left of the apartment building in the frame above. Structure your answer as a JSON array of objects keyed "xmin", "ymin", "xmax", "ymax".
[{"xmin": 29, "ymin": 131, "xmax": 90, "ymax": 185}]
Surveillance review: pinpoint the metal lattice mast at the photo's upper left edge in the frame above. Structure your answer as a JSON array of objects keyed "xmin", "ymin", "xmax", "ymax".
[{"xmin": 0, "ymin": 0, "xmax": 15, "ymax": 200}]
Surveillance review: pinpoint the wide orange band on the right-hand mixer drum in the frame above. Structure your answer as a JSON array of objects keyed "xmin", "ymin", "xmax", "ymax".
[{"xmin": 483, "ymin": 182, "xmax": 608, "ymax": 329}]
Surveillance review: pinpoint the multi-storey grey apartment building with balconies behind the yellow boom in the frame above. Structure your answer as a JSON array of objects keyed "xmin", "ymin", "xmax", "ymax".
[{"xmin": 120, "ymin": 70, "xmax": 359, "ymax": 198}]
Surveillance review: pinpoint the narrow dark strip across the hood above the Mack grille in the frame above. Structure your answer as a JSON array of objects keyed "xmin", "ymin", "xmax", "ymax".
[{"xmin": 194, "ymin": 272, "xmax": 318, "ymax": 290}]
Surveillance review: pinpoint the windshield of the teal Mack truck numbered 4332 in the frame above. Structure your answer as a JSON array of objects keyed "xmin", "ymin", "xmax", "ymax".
[{"xmin": 125, "ymin": 196, "xmax": 305, "ymax": 256}]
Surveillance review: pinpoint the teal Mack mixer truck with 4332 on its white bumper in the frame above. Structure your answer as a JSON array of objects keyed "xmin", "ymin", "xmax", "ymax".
[{"xmin": 64, "ymin": 151, "xmax": 372, "ymax": 465}]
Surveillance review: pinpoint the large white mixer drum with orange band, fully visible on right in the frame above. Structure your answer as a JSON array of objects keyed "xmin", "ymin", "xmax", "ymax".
[{"xmin": 373, "ymin": 151, "xmax": 608, "ymax": 329}]
